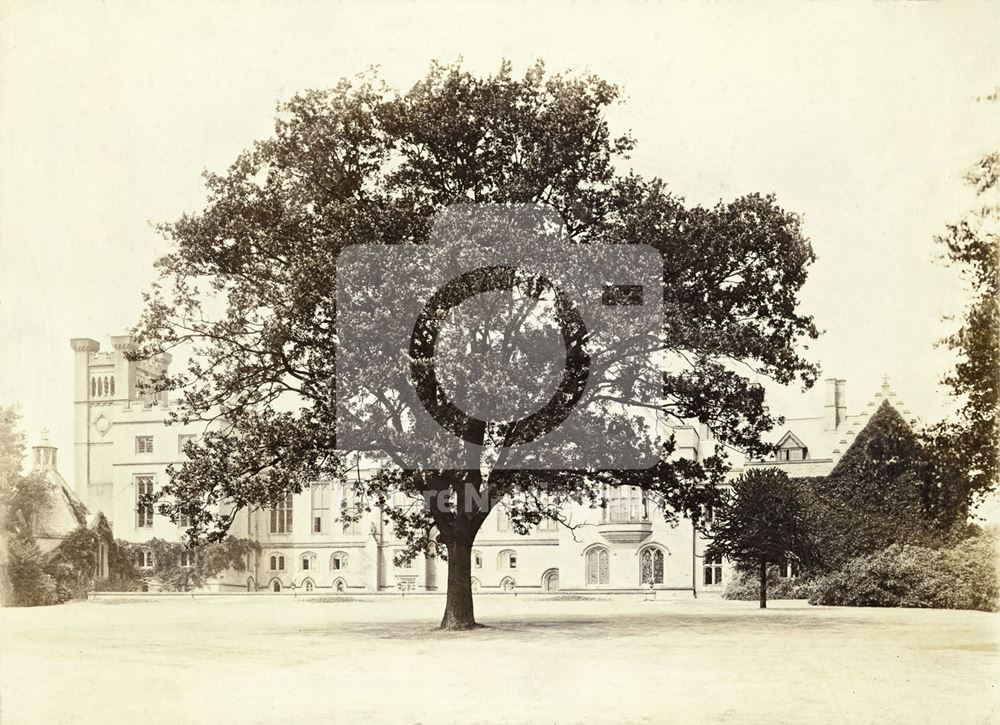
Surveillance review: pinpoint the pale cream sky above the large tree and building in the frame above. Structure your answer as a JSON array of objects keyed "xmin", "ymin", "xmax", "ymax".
[{"xmin": 0, "ymin": 0, "xmax": 1000, "ymax": 510}]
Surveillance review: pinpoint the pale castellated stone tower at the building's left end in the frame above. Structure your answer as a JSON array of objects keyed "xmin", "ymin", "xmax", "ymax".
[{"xmin": 70, "ymin": 335, "xmax": 201, "ymax": 541}]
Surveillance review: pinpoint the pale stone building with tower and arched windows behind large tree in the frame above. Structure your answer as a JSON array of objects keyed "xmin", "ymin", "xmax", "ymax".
[{"xmin": 68, "ymin": 336, "xmax": 909, "ymax": 596}]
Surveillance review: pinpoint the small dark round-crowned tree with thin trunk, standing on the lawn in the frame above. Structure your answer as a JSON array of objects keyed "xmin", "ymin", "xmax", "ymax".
[{"xmin": 705, "ymin": 468, "xmax": 819, "ymax": 609}]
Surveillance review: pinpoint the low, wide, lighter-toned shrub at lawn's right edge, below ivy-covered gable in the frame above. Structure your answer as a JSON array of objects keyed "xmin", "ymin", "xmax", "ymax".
[{"xmin": 809, "ymin": 531, "xmax": 1000, "ymax": 612}]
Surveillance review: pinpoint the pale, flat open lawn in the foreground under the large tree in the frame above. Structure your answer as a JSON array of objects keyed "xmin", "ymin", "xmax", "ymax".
[{"xmin": 0, "ymin": 595, "xmax": 1000, "ymax": 725}]
